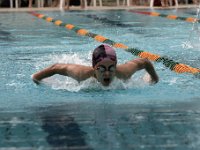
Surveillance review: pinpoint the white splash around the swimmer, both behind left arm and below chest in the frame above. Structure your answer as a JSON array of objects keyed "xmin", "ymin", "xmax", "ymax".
[{"xmin": 36, "ymin": 53, "xmax": 147, "ymax": 92}]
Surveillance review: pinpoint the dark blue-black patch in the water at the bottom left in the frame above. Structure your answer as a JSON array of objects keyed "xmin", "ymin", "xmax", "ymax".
[{"xmin": 41, "ymin": 107, "xmax": 92, "ymax": 150}]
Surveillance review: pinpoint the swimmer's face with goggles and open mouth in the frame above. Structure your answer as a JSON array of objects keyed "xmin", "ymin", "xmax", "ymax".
[{"xmin": 94, "ymin": 59, "xmax": 116, "ymax": 86}]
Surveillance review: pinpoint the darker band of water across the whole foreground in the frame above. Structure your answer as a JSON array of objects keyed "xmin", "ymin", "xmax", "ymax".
[{"xmin": 0, "ymin": 102, "xmax": 200, "ymax": 150}]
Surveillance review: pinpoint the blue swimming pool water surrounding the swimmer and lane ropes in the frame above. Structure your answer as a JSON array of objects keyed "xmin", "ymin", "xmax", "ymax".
[{"xmin": 0, "ymin": 9, "xmax": 200, "ymax": 150}]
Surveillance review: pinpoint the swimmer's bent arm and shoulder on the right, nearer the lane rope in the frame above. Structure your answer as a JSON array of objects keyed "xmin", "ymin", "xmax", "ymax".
[{"xmin": 117, "ymin": 58, "xmax": 159, "ymax": 83}]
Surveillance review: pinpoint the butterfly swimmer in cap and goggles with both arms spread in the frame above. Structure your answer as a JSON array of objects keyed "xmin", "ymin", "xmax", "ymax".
[{"xmin": 32, "ymin": 44, "xmax": 159, "ymax": 86}]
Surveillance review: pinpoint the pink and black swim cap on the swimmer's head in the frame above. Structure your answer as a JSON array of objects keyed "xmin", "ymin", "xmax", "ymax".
[{"xmin": 92, "ymin": 44, "xmax": 117, "ymax": 67}]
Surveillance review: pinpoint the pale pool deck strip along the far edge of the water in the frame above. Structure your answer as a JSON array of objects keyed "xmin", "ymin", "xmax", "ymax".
[{"xmin": 0, "ymin": 5, "xmax": 198, "ymax": 12}]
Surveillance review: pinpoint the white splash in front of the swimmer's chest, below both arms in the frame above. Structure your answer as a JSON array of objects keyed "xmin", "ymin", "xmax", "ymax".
[{"xmin": 44, "ymin": 72, "xmax": 147, "ymax": 92}]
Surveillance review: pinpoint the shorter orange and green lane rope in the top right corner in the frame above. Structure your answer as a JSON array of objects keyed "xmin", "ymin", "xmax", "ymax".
[{"xmin": 129, "ymin": 10, "xmax": 200, "ymax": 23}]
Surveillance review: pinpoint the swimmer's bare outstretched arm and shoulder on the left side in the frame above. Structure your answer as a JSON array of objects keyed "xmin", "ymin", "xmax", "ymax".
[{"xmin": 32, "ymin": 64, "xmax": 94, "ymax": 84}]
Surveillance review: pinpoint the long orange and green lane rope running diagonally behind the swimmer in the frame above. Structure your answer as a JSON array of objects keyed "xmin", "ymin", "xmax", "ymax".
[{"xmin": 31, "ymin": 12, "xmax": 200, "ymax": 77}]
